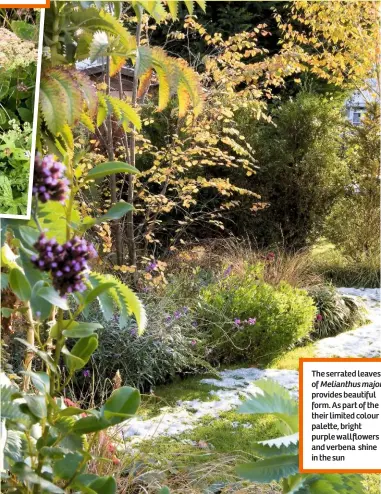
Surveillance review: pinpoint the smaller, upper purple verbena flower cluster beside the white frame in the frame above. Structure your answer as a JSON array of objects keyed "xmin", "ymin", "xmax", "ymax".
[{"xmin": 33, "ymin": 154, "xmax": 69, "ymax": 202}]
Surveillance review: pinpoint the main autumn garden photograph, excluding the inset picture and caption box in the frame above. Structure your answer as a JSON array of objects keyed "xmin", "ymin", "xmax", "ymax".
[{"xmin": 0, "ymin": 0, "xmax": 381, "ymax": 494}]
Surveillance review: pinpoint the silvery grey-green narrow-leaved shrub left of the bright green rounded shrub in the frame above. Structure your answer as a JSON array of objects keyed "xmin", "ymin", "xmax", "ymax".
[{"xmin": 76, "ymin": 298, "xmax": 206, "ymax": 399}]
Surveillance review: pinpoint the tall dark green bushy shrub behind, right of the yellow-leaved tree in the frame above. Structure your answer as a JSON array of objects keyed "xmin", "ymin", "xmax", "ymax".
[{"xmin": 236, "ymin": 92, "xmax": 344, "ymax": 250}]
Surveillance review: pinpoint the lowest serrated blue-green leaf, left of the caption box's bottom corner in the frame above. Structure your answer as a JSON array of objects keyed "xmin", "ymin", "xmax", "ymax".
[{"xmin": 237, "ymin": 455, "xmax": 299, "ymax": 484}]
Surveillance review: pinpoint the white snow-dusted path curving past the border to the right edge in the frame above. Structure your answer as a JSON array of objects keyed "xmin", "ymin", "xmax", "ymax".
[{"xmin": 120, "ymin": 288, "xmax": 381, "ymax": 445}]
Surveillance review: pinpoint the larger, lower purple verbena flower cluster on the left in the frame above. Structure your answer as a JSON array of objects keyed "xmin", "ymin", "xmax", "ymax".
[{"xmin": 31, "ymin": 233, "xmax": 97, "ymax": 296}]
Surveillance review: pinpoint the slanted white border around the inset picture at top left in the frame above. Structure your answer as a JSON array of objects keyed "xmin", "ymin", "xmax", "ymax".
[{"xmin": 0, "ymin": 9, "xmax": 45, "ymax": 220}]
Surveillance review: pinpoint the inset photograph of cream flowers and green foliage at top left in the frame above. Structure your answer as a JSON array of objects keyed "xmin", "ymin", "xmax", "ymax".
[{"xmin": 0, "ymin": 9, "xmax": 44, "ymax": 219}]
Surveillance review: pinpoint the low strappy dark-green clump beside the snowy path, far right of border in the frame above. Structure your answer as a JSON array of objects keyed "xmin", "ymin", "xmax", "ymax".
[{"xmin": 308, "ymin": 285, "xmax": 366, "ymax": 339}]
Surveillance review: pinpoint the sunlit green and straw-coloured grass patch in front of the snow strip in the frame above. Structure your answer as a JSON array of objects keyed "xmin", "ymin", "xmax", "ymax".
[{"xmin": 134, "ymin": 411, "xmax": 279, "ymax": 494}]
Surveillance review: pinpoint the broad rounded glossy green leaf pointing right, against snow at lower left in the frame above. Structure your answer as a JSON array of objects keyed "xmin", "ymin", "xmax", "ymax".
[{"xmin": 101, "ymin": 386, "xmax": 140, "ymax": 425}]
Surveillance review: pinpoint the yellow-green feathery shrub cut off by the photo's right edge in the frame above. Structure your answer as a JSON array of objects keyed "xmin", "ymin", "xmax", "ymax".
[{"xmin": 325, "ymin": 103, "xmax": 380, "ymax": 261}]
